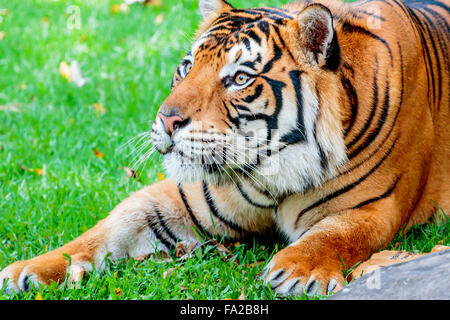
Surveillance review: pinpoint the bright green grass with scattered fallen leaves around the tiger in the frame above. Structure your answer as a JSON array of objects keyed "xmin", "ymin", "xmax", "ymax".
[{"xmin": 0, "ymin": 0, "xmax": 450, "ymax": 299}]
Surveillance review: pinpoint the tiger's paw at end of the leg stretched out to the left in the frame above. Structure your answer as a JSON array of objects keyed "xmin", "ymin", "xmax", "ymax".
[{"xmin": 0, "ymin": 255, "xmax": 85, "ymax": 294}]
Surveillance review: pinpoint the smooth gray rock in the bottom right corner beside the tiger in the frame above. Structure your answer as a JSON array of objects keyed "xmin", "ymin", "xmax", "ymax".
[{"xmin": 329, "ymin": 250, "xmax": 450, "ymax": 300}]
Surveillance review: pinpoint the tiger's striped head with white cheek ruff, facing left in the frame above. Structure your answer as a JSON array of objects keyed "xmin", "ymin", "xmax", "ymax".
[{"xmin": 151, "ymin": 0, "xmax": 346, "ymax": 193}]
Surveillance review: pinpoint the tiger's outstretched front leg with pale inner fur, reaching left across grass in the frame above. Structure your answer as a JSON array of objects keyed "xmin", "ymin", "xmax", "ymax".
[{"xmin": 0, "ymin": 180, "xmax": 270, "ymax": 292}]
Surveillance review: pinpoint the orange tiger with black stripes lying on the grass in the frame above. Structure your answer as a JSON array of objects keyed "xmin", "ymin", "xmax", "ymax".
[{"xmin": 0, "ymin": 0, "xmax": 450, "ymax": 296}]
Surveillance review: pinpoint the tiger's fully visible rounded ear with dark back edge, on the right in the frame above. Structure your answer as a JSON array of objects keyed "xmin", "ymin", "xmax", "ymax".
[{"xmin": 296, "ymin": 4, "xmax": 340, "ymax": 70}]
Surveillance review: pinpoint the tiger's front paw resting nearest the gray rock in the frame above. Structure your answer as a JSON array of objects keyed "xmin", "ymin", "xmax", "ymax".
[{"xmin": 262, "ymin": 246, "xmax": 344, "ymax": 296}]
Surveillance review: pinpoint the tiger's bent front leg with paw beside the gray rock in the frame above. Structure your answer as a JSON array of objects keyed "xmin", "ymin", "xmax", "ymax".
[{"xmin": 262, "ymin": 195, "xmax": 399, "ymax": 295}]
